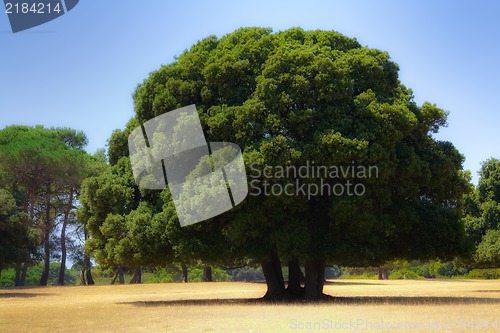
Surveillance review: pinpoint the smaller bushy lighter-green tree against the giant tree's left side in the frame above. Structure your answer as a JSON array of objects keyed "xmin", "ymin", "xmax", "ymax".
[{"xmin": 77, "ymin": 152, "xmax": 171, "ymax": 283}]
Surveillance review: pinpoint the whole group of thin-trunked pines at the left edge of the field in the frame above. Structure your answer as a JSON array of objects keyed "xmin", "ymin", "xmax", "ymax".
[{"xmin": 0, "ymin": 126, "xmax": 104, "ymax": 286}]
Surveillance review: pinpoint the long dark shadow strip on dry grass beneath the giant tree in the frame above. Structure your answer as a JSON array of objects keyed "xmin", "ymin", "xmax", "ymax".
[{"xmin": 119, "ymin": 296, "xmax": 500, "ymax": 307}]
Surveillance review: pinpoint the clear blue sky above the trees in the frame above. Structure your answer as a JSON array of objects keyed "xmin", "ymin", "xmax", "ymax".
[{"xmin": 0, "ymin": 0, "xmax": 500, "ymax": 181}]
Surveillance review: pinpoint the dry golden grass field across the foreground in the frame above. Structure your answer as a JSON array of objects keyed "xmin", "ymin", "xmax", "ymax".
[{"xmin": 0, "ymin": 280, "xmax": 500, "ymax": 333}]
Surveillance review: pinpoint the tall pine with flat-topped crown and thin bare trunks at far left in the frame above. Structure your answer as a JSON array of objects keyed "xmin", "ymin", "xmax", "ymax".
[{"xmin": 0, "ymin": 126, "xmax": 87, "ymax": 285}]
